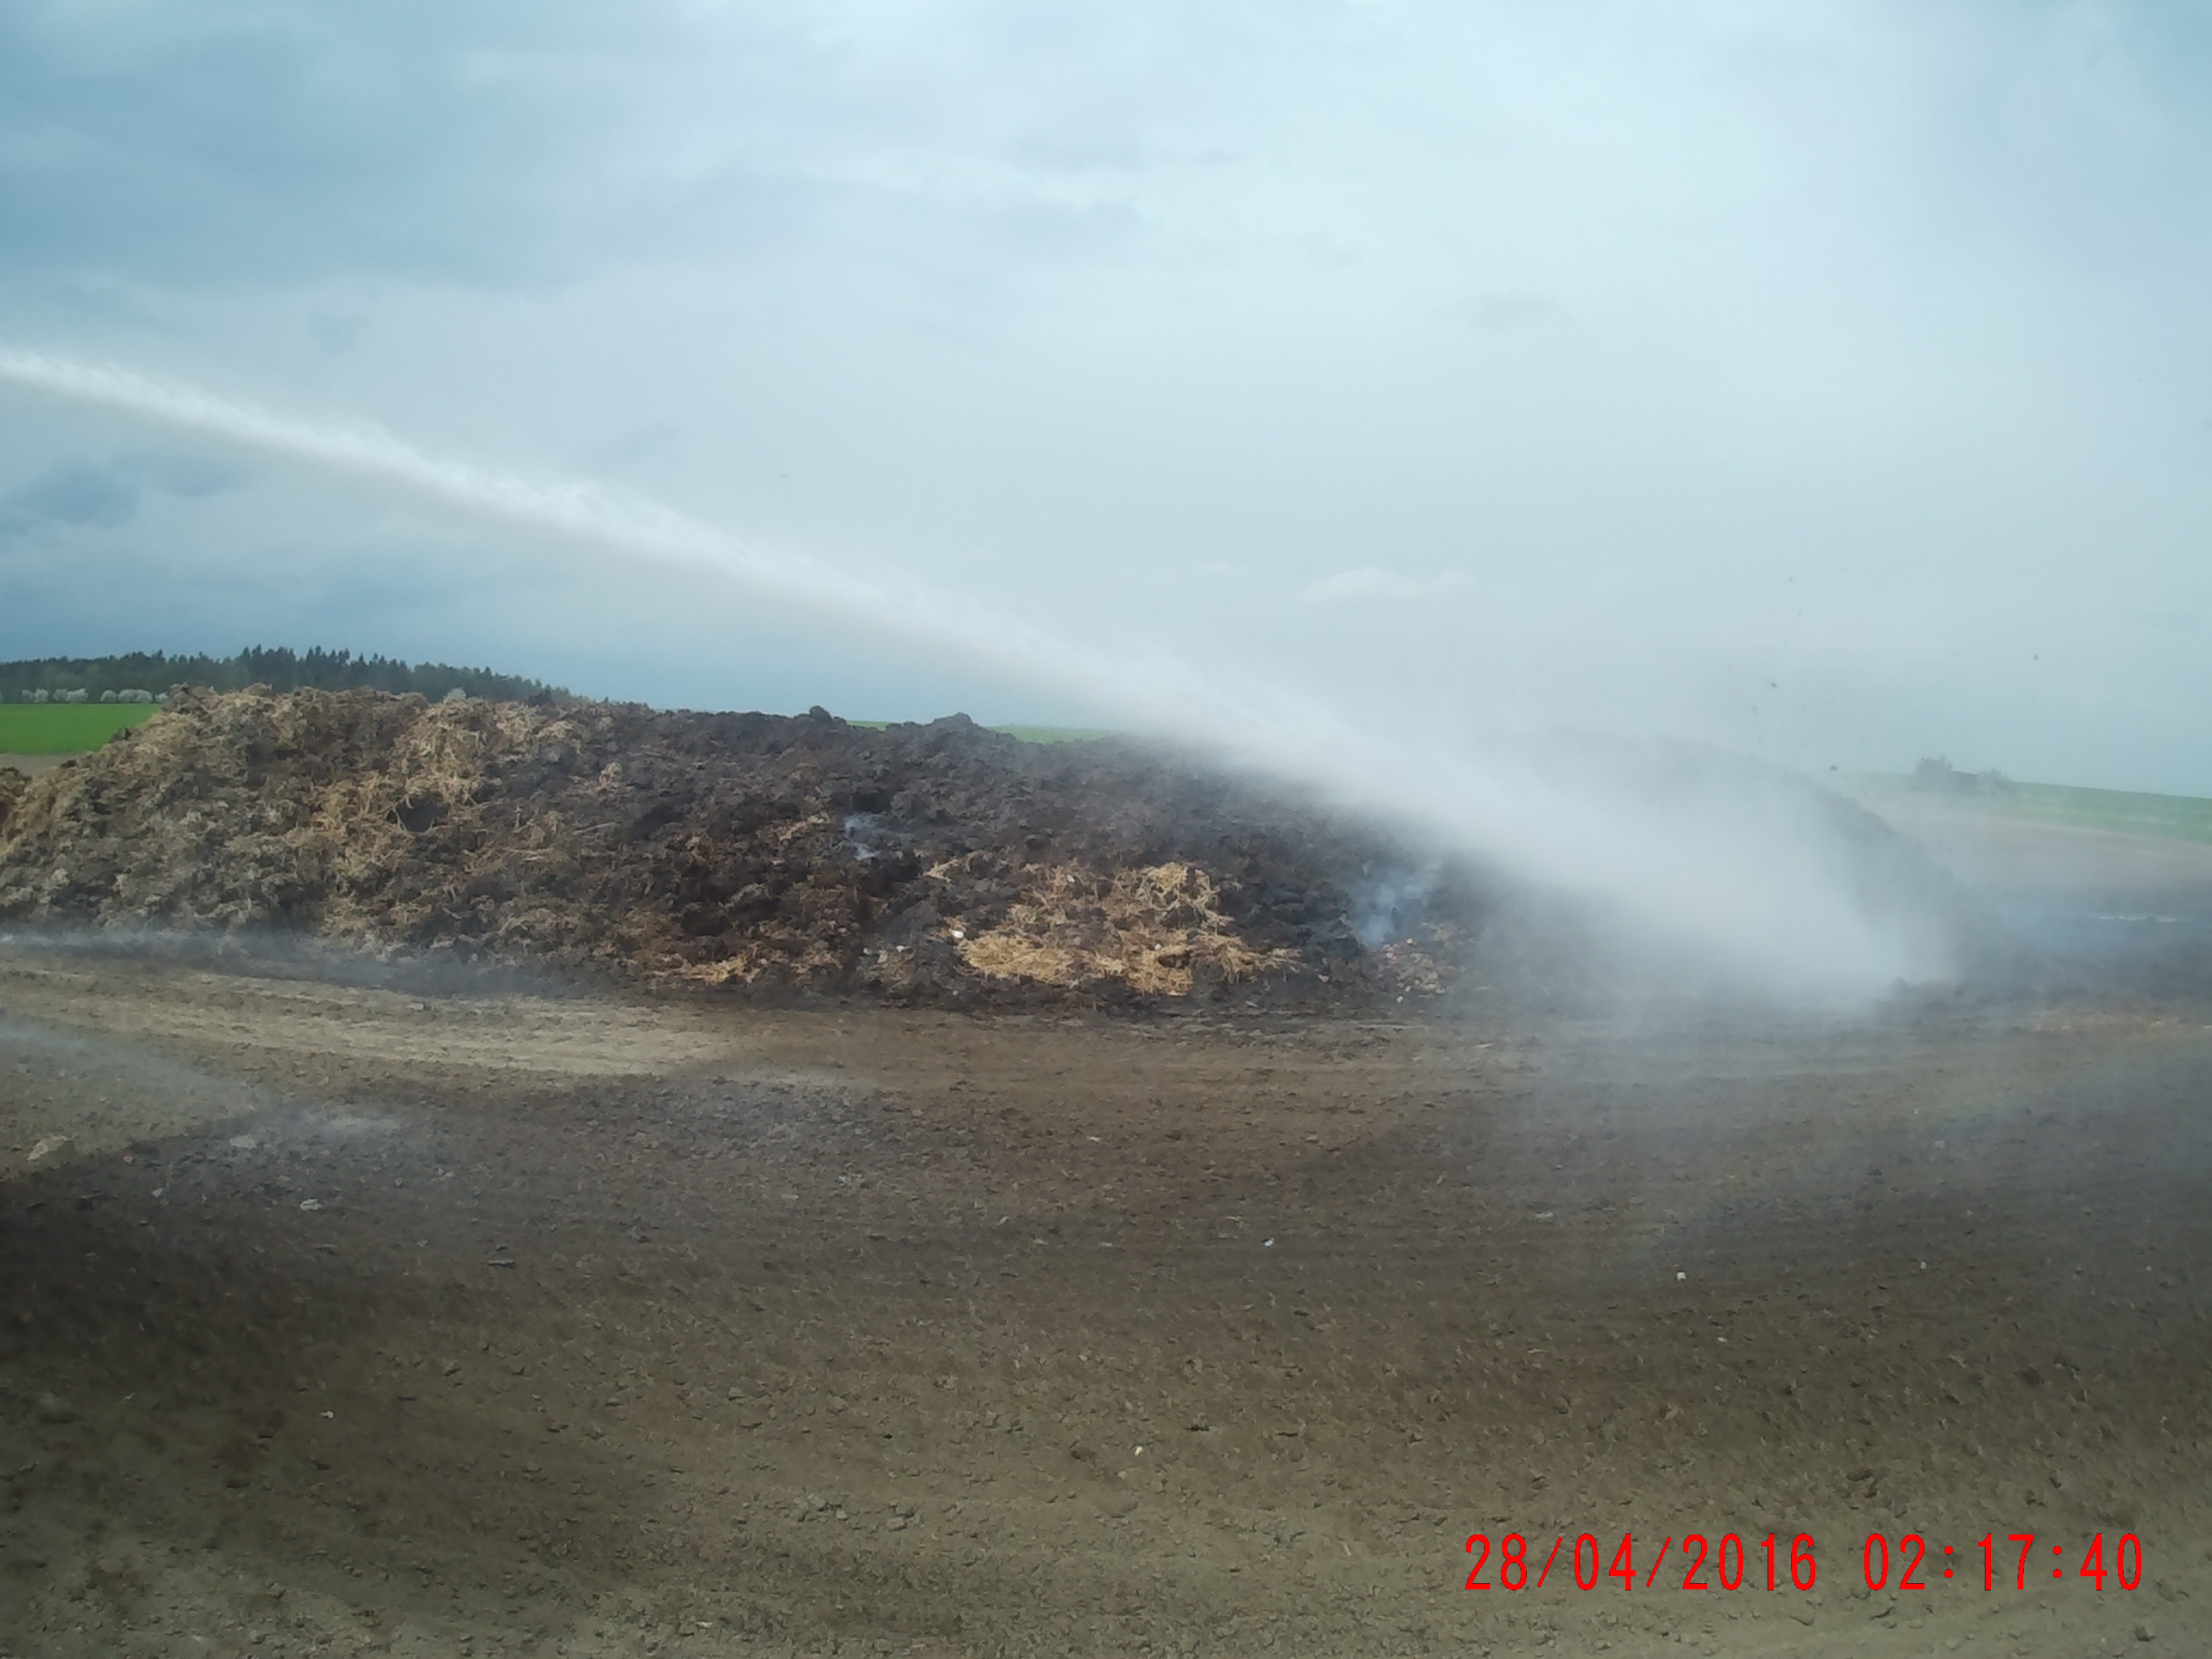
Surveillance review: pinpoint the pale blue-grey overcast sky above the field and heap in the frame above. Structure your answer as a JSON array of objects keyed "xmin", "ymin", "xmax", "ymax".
[{"xmin": 0, "ymin": 0, "xmax": 2212, "ymax": 794}]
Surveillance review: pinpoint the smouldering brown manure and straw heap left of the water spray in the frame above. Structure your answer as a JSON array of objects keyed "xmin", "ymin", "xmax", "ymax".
[{"xmin": 0, "ymin": 688, "xmax": 1482, "ymax": 1005}]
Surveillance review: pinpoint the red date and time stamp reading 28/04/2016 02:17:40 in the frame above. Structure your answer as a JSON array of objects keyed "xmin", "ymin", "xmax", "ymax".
[{"xmin": 1466, "ymin": 1533, "xmax": 2143, "ymax": 1590}]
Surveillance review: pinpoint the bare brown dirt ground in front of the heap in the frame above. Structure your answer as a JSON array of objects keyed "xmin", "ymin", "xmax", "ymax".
[{"xmin": 0, "ymin": 814, "xmax": 2212, "ymax": 1659}]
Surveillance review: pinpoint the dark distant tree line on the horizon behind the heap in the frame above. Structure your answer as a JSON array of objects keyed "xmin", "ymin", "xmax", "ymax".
[{"xmin": 0, "ymin": 646, "xmax": 568, "ymax": 703}]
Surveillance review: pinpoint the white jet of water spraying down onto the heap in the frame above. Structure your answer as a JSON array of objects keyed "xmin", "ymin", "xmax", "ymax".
[{"xmin": 0, "ymin": 349, "xmax": 1951, "ymax": 1000}]
